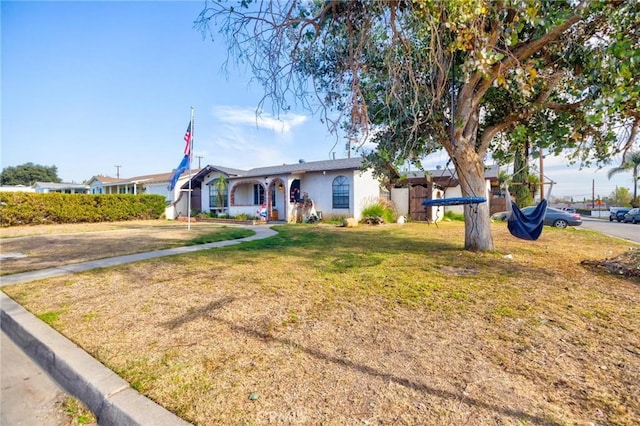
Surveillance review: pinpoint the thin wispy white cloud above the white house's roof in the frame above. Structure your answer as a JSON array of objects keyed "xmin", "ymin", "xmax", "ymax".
[{"xmin": 213, "ymin": 106, "xmax": 308, "ymax": 133}]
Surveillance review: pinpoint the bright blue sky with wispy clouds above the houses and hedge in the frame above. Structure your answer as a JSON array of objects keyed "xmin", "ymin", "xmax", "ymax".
[{"xmin": 0, "ymin": 1, "xmax": 632, "ymax": 198}]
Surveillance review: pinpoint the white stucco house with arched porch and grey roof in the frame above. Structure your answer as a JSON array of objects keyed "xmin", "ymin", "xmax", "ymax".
[{"xmin": 183, "ymin": 158, "xmax": 380, "ymax": 222}]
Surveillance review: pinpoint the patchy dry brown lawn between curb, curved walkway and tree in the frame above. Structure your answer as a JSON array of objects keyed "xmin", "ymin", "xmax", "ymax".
[{"xmin": 3, "ymin": 223, "xmax": 640, "ymax": 425}]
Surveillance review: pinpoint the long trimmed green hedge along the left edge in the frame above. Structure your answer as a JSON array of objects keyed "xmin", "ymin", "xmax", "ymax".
[{"xmin": 0, "ymin": 192, "xmax": 166, "ymax": 226}]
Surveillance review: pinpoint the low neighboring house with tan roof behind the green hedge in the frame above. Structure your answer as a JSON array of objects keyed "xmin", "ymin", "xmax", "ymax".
[{"xmin": 88, "ymin": 169, "xmax": 199, "ymax": 219}]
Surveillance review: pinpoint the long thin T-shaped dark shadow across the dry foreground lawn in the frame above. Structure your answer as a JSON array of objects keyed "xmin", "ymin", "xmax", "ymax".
[{"xmin": 162, "ymin": 297, "xmax": 556, "ymax": 425}]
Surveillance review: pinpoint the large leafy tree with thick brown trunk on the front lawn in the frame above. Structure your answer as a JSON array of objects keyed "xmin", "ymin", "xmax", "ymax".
[{"xmin": 197, "ymin": 0, "xmax": 640, "ymax": 250}]
